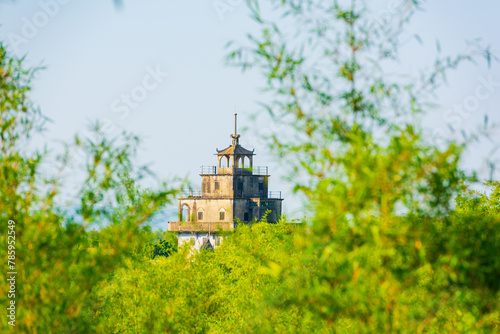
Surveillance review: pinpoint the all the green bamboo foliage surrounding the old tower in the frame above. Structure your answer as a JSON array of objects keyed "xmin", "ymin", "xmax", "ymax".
[{"xmin": 0, "ymin": 0, "xmax": 500, "ymax": 333}]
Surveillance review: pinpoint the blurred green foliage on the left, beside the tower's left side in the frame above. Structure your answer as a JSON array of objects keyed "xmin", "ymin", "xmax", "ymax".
[{"xmin": 0, "ymin": 43, "xmax": 180, "ymax": 333}]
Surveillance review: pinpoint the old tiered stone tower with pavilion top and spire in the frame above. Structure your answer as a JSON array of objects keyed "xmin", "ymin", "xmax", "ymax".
[{"xmin": 168, "ymin": 114, "xmax": 283, "ymax": 249}]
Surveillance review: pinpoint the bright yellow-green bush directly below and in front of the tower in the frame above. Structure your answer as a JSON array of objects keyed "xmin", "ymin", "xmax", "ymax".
[{"xmin": 88, "ymin": 221, "xmax": 314, "ymax": 333}]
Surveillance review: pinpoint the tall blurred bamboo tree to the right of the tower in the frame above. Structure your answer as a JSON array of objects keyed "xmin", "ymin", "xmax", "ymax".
[{"xmin": 228, "ymin": 0, "xmax": 498, "ymax": 333}]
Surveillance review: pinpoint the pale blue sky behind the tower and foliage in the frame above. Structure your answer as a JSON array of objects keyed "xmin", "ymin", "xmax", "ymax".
[{"xmin": 0, "ymin": 0, "xmax": 500, "ymax": 224}]
